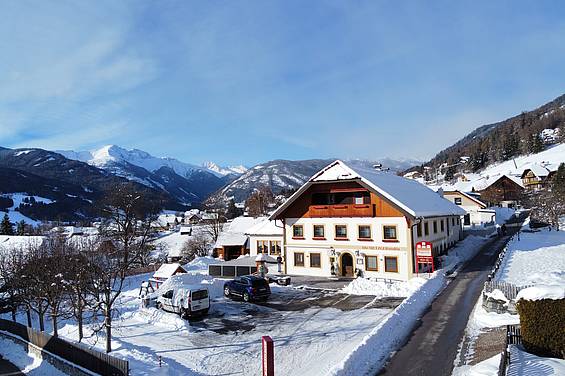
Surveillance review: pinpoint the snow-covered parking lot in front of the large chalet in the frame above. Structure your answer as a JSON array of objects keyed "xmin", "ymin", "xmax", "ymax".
[{"xmin": 101, "ymin": 280, "xmax": 402, "ymax": 376}]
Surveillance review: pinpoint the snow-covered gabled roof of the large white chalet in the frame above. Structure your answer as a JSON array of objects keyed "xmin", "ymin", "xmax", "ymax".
[{"xmin": 270, "ymin": 160, "xmax": 466, "ymax": 219}]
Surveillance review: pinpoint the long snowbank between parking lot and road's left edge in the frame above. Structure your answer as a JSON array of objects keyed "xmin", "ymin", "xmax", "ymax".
[{"xmin": 330, "ymin": 236, "xmax": 488, "ymax": 376}]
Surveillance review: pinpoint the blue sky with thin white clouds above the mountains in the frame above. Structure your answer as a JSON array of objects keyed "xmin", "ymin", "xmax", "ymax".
[{"xmin": 0, "ymin": 0, "xmax": 565, "ymax": 165}]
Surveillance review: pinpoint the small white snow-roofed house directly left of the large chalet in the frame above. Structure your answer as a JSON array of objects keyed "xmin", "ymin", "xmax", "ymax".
[{"xmin": 246, "ymin": 218, "xmax": 283, "ymax": 258}]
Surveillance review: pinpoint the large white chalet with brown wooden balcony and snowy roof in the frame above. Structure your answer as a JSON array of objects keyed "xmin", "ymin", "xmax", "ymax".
[{"xmin": 270, "ymin": 160, "xmax": 466, "ymax": 280}]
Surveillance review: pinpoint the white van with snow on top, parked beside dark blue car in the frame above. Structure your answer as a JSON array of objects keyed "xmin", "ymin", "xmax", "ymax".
[{"xmin": 157, "ymin": 285, "xmax": 210, "ymax": 318}]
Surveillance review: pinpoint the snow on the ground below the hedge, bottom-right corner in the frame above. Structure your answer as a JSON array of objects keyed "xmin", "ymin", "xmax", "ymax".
[{"xmin": 506, "ymin": 345, "xmax": 565, "ymax": 376}]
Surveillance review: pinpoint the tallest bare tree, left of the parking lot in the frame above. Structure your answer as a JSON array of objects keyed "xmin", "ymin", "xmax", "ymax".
[{"xmin": 90, "ymin": 184, "xmax": 161, "ymax": 352}]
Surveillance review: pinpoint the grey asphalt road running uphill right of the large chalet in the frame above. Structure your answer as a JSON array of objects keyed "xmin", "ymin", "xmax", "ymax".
[{"xmin": 379, "ymin": 229, "xmax": 515, "ymax": 376}]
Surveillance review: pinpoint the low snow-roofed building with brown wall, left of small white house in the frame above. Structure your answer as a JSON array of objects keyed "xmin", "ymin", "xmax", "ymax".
[{"xmin": 214, "ymin": 217, "xmax": 262, "ymax": 261}]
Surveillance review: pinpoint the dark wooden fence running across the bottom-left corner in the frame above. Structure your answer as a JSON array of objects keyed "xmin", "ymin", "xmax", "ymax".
[{"xmin": 0, "ymin": 319, "xmax": 129, "ymax": 376}]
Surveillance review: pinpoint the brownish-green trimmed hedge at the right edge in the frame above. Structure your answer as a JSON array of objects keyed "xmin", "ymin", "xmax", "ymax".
[{"xmin": 516, "ymin": 299, "xmax": 565, "ymax": 359}]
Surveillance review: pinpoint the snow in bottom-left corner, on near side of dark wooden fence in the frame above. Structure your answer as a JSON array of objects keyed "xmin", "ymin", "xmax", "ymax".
[{"xmin": 0, "ymin": 337, "xmax": 65, "ymax": 376}]
